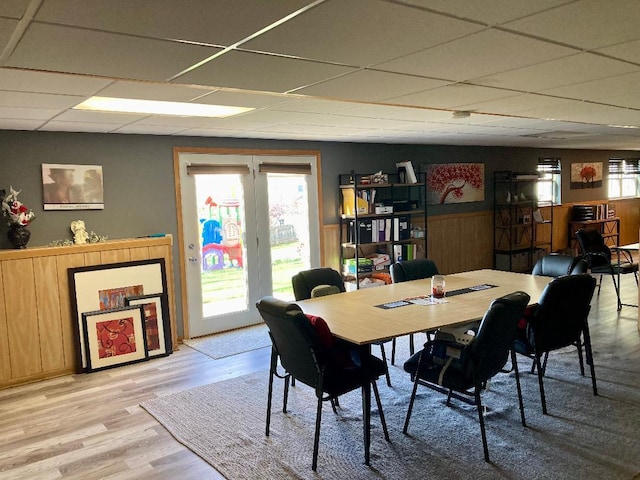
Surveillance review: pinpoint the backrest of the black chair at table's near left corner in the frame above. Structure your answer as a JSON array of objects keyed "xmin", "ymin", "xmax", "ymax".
[{"xmin": 256, "ymin": 296, "xmax": 326, "ymax": 388}]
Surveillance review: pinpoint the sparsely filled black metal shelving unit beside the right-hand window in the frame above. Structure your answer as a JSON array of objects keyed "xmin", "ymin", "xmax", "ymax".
[{"xmin": 493, "ymin": 171, "xmax": 553, "ymax": 272}]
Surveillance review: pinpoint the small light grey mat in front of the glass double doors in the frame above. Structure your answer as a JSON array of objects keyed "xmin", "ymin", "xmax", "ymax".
[{"xmin": 183, "ymin": 323, "xmax": 271, "ymax": 359}]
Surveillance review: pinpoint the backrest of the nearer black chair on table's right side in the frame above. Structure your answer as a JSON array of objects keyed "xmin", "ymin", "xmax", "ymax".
[{"xmin": 467, "ymin": 292, "xmax": 530, "ymax": 382}]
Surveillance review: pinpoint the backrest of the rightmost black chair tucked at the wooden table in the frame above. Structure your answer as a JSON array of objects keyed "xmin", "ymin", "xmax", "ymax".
[{"xmin": 530, "ymin": 273, "xmax": 596, "ymax": 351}]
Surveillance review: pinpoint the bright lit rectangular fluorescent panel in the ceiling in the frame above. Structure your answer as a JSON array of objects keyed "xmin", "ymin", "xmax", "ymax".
[{"xmin": 73, "ymin": 97, "xmax": 253, "ymax": 117}]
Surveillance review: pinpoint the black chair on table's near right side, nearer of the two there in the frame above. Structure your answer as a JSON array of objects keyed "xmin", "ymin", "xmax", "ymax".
[{"xmin": 403, "ymin": 292, "xmax": 529, "ymax": 462}]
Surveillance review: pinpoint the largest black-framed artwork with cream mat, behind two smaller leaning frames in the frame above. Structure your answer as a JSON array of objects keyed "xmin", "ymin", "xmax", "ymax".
[{"xmin": 68, "ymin": 258, "xmax": 168, "ymax": 371}]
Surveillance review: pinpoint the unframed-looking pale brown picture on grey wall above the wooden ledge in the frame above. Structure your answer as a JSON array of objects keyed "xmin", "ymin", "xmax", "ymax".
[{"xmin": 42, "ymin": 163, "xmax": 104, "ymax": 210}]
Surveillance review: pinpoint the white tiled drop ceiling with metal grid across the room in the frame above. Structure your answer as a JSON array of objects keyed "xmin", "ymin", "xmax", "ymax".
[{"xmin": 0, "ymin": 0, "xmax": 640, "ymax": 150}]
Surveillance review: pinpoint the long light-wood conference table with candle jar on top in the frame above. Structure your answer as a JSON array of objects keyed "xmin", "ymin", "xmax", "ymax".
[{"xmin": 296, "ymin": 270, "xmax": 552, "ymax": 465}]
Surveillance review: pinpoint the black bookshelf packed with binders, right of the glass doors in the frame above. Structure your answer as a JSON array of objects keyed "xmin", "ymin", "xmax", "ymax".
[{"xmin": 339, "ymin": 172, "xmax": 427, "ymax": 288}]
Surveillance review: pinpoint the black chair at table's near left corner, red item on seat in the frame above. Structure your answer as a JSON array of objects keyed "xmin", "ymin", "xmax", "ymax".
[{"xmin": 256, "ymin": 297, "xmax": 389, "ymax": 471}]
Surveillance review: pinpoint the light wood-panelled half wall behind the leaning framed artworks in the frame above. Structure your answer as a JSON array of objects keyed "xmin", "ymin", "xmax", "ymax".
[{"xmin": 0, "ymin": 236, "xmax": 178, "ymax": 388}]
